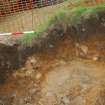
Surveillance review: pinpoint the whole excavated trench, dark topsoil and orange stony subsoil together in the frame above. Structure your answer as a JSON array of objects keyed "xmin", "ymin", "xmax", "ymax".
[{"xmin": 0, "ymin": 12, "xmax": 105, "ymax": 105}]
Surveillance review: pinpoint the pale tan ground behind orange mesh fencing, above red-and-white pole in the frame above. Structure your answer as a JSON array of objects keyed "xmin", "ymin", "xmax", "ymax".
[{"xmin": 0, "ymin": 0, "xmax": 67, "ymax": 33}]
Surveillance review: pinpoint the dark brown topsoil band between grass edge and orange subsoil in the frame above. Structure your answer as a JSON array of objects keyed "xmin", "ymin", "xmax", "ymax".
[{"xmin": 0, "ymin": 12, "xmax": 105, "ymax": 82}]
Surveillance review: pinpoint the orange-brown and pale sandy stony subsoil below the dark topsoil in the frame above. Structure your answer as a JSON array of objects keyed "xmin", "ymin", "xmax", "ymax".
[{"xmin": 0, "ymin": 35, "xmax": 105, "ymax": 105}]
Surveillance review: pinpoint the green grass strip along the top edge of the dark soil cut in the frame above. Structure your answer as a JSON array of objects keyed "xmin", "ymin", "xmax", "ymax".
[{"xmin": 19, "ymin": 0, "xmax": 105, "ymax": 42}]
